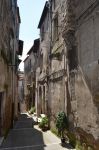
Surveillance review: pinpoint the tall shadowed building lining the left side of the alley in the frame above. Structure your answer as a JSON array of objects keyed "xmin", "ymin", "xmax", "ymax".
[{"xmin": 0, "ymin": 0, "xmax": 23, "ymax": 136}]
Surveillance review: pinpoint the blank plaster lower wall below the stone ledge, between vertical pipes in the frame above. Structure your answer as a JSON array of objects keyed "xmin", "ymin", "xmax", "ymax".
[{"xmin": 50, "ymin": 78, "xmax": 65, "ymax": 127}]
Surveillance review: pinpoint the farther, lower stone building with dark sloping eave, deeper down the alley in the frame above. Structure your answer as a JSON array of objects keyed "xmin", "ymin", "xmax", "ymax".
[{"xmin": 24, "ymin": 39, "xmax": 39, "ymax": 109}]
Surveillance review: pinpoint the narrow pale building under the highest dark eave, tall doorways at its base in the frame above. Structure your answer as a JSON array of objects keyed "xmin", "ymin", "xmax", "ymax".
[{"xmin": 37, "ymin": 2, "xmax": 50, "ymax": 115}]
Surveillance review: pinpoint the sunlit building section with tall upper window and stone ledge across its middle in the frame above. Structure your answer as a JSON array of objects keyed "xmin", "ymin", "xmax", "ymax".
[{"xmin": 49, "ymin": 0, "xmax": 67, "ymax": 127}]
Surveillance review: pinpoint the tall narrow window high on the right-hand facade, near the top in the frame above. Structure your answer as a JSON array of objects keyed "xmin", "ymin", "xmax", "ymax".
[{"xmin": 53, "ymin": 15, "xmax": 58, "ymax": 41}]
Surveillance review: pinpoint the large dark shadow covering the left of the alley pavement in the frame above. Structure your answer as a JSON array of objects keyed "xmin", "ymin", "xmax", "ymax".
[{"xmin": 0, "ymin": 114, "xmax": 46, "ymax": 150}]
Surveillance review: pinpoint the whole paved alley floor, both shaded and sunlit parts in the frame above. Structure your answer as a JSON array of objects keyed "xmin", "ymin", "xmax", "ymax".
[{"xmin": 0, "ymin": 113, "xmax": 72, "ymax": 150}]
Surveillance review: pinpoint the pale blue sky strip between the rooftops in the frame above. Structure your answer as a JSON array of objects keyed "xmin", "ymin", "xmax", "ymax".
[{"xmin": 18, "ymin": 0, "xmax": 46, "ymax": 70}]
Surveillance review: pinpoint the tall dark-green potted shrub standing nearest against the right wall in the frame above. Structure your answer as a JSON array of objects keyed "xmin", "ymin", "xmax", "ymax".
[{"xmin": 56, "ymin": 111, "xmax": 68, "ymax": 143}]
